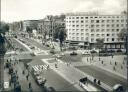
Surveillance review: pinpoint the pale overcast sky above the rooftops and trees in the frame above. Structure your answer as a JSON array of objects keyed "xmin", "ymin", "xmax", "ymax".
[{"xmin": 1, "ymin": 0, "xmax": 127, "ymax": 22}]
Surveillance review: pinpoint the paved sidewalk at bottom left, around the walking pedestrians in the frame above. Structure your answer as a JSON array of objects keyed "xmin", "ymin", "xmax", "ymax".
[{"xmin": 4, "ymin": 57, "xmax": 42, "ymax": 92}]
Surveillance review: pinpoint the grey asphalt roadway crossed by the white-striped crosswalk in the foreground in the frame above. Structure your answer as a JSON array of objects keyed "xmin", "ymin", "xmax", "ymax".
[{"xmin": 30, "ymin": 59, "xmax": 78, "ymax": 91}]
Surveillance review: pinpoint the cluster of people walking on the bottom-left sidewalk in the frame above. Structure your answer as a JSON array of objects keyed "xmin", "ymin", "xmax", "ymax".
[{"xmin": 4, "ymin": 56, "xmax": 32, "ymax": 92}]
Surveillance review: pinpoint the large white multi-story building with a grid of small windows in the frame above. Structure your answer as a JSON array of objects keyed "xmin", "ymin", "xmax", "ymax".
[{"xmin": 65, "ymin": 13, "xmax": 127, "ymax": 48}]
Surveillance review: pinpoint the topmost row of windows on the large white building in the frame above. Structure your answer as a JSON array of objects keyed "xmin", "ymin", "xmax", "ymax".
[{"xmin": 66, "ymin": 16, "xmax": 126, "ymax": 19}]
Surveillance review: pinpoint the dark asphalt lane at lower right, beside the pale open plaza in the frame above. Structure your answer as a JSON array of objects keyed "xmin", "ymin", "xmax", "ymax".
[{"xmin": 76, "ymin": 66, "xmax": 127, "ymax": 88}]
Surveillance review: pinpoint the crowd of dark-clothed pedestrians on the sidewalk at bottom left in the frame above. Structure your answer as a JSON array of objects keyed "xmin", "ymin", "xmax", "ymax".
[{"xmin": 4, "ymin": 55, "xmax": 32, "ymax": 92}]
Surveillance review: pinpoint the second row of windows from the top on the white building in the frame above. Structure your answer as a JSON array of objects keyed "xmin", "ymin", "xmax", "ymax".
[{"xmin": 66, "ymin": 19, "xmax": 125, "ymax": 23}]
